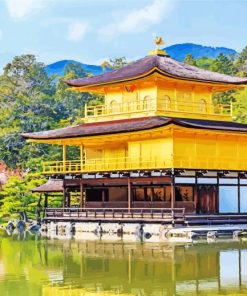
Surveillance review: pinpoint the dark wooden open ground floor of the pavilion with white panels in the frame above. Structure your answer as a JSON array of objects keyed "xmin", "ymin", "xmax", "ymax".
[{"xmin": 37, "ymin": 171, "xmax": 247, "ymax": 224}]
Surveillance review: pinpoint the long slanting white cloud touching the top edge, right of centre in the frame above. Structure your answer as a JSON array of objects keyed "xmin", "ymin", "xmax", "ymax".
[{"xmin": 99, "ymin": 0, "xmax": 172, "ymax": 39}]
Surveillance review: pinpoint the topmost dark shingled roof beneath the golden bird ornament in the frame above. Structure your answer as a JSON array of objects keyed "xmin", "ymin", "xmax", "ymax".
[{"xmin": 65, "ymin": 55, "xmax": 247, "ymax": 87}]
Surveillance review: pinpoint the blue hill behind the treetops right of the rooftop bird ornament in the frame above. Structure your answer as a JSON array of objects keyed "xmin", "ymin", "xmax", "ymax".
[{"xmin": 164, "ymin": 43, "xmax": 237, "ymax": 62}]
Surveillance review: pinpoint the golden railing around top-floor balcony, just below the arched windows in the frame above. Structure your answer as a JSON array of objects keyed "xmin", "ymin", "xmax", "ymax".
[{"xmin": 85, "ymin": 99, "xmax": 232, "ymax": 118}]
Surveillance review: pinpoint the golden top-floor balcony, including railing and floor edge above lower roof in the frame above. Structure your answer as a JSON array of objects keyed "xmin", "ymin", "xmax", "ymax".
[{"xmin": 85, "ymin": 99, "xmax": 232, "ymax": 121}]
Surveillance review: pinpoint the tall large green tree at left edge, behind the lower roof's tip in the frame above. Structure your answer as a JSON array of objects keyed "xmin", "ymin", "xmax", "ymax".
[{"xmin": 0, "ymin": 55, "xmax": 59, "ymax": 167}]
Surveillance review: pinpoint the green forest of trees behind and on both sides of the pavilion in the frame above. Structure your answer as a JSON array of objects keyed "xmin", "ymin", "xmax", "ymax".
[{"xmin": 0, "ymin": 46, "xmax": 247, "ymax": 217}]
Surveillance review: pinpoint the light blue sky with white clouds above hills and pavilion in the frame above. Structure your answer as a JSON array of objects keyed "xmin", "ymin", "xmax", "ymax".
[{"xmin": 0, "ymin": 0, "xmax": 247, "ymax": 68}]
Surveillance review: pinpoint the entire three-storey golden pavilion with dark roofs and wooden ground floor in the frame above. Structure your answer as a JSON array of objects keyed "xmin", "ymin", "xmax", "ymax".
[{"xmin": 23, "ymin": 42, "xmax": 247, "ymax": 224}]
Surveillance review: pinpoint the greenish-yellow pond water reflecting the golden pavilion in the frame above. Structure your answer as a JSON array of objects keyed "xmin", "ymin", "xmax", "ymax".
[{"xmin": 0, "ymin": 230, "xmax": 247, "ymax": 296}]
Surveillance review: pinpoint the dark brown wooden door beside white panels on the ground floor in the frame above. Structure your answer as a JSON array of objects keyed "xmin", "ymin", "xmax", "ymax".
[{"xmin": 197, "ymin": 185, "xmax": 217, "ymax": 214}]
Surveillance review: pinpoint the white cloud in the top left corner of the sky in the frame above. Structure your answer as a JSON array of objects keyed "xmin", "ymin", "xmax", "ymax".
[{"xmin": 5, "ymin": 0, "xmax": 44, "ymax": 21}]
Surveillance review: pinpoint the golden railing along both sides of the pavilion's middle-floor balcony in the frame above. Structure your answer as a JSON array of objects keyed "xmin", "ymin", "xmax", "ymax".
[{"xmin": 43, "ymin": 155, "xmax": 247, "ymax": 174}]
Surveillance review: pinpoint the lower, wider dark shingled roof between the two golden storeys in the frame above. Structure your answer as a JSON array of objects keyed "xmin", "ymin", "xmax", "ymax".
[{"xmin": 22, "ymin": 116, "xmax": 247, "ymax": 140}]
